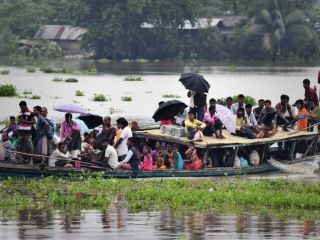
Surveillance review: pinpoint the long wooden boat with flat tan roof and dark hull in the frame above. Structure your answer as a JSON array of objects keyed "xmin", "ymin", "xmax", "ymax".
[{"xmin": 0, "ymin": 130, "xmax": 318, "ymax": 178}]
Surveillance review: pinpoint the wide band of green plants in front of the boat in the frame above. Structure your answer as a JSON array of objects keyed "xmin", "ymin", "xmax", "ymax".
[{"xmin": 0, "ymin": 176, "xmax": 320, "ymax": 219}]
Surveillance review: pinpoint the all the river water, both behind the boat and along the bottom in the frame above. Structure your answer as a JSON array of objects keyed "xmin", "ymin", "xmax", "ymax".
[{"xmin": 0, "ymin": 60, "xmax": 320, "ymax": 240}]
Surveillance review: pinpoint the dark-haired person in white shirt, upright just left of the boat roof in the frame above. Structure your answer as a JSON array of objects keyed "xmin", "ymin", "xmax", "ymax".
[{"xmin": 114, "ymin": 118, "xmax": 132, "ymax": 162}]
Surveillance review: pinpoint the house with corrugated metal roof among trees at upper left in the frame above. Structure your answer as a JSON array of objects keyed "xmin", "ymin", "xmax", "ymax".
[{"xmin": 33, "ymin": 25, "xmax": 88, "ymax": 56}]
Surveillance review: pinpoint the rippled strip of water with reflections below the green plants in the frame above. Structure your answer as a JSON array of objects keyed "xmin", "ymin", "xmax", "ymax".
[{"xmin": 0, "ymin": 205, "xmax": 320, "ymax": 240}]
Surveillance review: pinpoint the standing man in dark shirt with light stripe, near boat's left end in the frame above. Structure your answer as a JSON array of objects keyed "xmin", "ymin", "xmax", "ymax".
[{"xmin": 18, "ymin": 101, "xmax": 36, "ymax": 165}]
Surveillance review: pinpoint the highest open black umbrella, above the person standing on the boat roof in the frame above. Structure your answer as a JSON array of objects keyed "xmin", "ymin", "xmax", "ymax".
[{"xmin": 179, "ymin": 73, "xmax": 210, "ymax": 93}]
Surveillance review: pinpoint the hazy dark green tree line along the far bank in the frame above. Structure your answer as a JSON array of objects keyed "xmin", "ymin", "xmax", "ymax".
[{"xmin": 0, "ymin": 0, "xmax": 320, "ymax": 61}]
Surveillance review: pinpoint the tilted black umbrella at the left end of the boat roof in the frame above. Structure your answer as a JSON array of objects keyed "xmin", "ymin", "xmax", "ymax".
[{"xmin": 152, "ymin": 100, "xmax": 187, "ymax": 122}]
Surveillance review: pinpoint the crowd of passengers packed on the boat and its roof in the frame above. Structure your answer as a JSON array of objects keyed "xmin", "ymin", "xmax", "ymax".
[{"xmin": 1, "ymin": 79, "xmax": 320, "ymax": 174}]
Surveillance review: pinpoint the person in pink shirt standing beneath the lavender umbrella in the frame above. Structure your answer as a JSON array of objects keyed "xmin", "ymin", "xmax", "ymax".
[{"xmin": 60, "ymin": 113, "xmax": 82, "ymax": 158}]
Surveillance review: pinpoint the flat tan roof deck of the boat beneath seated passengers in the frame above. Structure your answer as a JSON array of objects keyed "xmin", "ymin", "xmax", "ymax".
[{"xmin": 134, "ymin": 129, "xmax": 318, "ymax": 148}]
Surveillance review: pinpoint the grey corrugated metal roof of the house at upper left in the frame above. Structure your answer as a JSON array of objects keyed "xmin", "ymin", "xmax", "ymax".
[{"xmin": 33, "ymin": 25, "xmax": 87, "ymax": 40}]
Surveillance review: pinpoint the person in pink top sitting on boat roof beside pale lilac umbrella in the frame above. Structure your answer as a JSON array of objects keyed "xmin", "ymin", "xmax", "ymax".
[{"xmin": 203, "ymin": 104, "xmax": 224, "ymax": 139}]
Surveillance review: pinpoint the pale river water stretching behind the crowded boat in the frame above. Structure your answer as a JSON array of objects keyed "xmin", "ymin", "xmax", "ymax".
[{"xmin": 0, "ymin": 60, "xmax": 318, "ymax": 123}]
